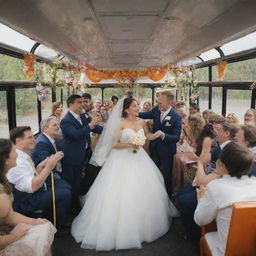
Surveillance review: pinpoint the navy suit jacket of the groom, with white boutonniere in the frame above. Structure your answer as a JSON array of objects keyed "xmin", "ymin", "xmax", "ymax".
[{"xmin": 139, "ymin": 106, "xmax": 182, "ymax": 156}]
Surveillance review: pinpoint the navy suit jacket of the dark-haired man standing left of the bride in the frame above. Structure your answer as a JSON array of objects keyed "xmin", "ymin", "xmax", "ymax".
[{"xmin": 60, "ymin": 112, "xmax": 103, "ymax": 166}]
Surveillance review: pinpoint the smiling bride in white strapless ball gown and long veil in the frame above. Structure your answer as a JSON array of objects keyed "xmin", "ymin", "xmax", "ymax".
[{"xmin": 71, "ymin": 98, "xmax": 177, "ymax": 251}]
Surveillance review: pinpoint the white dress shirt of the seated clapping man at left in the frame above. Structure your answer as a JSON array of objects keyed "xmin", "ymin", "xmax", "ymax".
[{"xmin": 6, "ymin": 149, "xmax": 35, "ymax": 193}]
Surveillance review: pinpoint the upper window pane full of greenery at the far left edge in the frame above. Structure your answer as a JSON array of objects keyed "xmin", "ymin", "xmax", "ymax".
[{"xmin": 0, "ymin": 54, "xmax": 26, "ymax": 80}]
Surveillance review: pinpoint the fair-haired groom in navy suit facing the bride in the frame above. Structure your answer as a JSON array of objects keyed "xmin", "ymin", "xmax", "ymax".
[{"xmin": 139, "ymin": 90, "xmax": 182, "ymax": 196}]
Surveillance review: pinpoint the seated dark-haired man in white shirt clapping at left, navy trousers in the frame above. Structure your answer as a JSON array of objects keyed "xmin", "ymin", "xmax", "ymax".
[{"xmin": 7, "ymin": 126, "xmax": 71, "ymax": 229}]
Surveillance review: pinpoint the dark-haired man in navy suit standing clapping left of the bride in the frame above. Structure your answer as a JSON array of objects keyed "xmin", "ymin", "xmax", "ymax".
[{"xmin": 60, "ymin": 94, "xmax": 103, "ymax": 214}]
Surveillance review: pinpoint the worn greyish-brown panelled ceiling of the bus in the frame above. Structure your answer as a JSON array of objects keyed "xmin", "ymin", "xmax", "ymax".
[{"xmin": 0, "ymin": 0, "xmax": 256, "ymax": 68}]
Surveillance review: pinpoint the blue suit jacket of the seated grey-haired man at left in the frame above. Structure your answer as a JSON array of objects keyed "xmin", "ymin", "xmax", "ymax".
[{"xmin": 30, "ymin": 133, "xmax": 56, "ymax": 165}]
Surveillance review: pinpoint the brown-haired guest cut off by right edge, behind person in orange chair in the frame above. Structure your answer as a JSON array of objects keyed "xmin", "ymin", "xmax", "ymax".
[{"xmin": 235, "ymin": 125, "xmax": 256, "ymax": 176}]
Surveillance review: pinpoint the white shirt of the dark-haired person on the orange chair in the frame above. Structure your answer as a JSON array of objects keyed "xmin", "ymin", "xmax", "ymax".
[{"xmin": 194, "ymin": 175, "xmax": 256, "ymax": 256}]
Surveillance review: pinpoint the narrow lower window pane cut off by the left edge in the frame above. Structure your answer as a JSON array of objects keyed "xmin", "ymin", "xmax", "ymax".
[{"xmin": 0, "ymin": 91, "xmax": 9, "ymax": 138}]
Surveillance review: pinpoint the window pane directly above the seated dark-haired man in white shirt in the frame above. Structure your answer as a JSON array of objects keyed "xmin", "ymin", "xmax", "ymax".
[{"xmin": 15, "ymin": 88, "xmax": 39, "ymax": 133}]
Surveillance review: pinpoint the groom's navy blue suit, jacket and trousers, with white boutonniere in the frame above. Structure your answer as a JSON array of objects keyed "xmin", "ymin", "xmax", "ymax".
[{"xmin": 139, "ymin": 107, "xmax": 182, "ymax": 195}]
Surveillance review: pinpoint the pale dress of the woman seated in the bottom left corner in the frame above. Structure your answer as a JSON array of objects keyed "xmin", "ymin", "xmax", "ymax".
[{"xmin": 0, "ymin": 184, "xmax": 56, "ymax": 256}]
